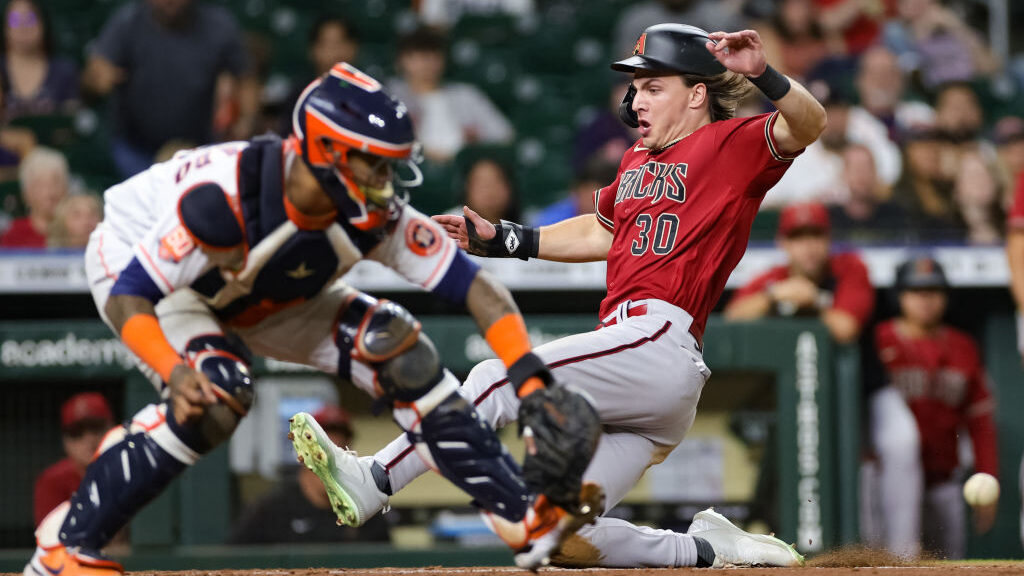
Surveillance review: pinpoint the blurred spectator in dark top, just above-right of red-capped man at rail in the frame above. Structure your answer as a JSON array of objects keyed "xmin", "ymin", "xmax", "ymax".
[{"xmin": 828, "ymin": 145, "xmax": 912, "ymax": 244}]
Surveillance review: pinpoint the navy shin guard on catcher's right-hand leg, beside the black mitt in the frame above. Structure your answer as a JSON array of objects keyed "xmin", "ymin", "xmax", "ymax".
[{"xmin": 409, "ymin": 392, "xmax": 529, "ymax": 522}]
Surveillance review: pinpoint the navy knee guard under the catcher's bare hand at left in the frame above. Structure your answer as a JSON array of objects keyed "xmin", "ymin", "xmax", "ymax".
[{"xmin": 161, "ymin": 335, "xmax": 255, "ymax": 454}]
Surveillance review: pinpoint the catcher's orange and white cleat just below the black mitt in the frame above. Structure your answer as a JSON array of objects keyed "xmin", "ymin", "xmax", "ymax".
[{"xmin": 483, "ymin": 484, "xmax": 604, "ymax": 572}]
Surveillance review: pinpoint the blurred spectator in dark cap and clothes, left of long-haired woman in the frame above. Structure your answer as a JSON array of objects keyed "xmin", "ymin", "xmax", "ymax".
[{"xmin": 893, "ymin": 126, "xmax": 964, "ymax": 242}]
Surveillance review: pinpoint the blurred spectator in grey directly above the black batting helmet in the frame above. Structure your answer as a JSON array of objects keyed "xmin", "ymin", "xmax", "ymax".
[{"xmin": 612, "ymin": 0, "xmax": 743, "ymax": 59}]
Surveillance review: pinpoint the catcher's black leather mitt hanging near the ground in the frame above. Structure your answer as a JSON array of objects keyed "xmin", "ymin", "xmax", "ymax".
[{"xmin": 519, "ymin": 384, "xmax": 601, "ymax": 513}]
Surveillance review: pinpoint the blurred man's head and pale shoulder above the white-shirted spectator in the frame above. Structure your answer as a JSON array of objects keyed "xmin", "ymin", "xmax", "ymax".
[{"xmin": 856, "ymin": 45, "xmax": 935, "ymax": 142}]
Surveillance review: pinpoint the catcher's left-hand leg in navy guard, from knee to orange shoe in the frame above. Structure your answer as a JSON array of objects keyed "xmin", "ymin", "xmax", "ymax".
[{"xmin": 27, "ymin": 335, "xmax": 253, "ymax": 576}]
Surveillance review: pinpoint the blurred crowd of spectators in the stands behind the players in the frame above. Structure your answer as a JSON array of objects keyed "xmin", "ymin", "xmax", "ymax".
[{"xmin": 0, "ymin": 0, "xmax": 1024, "ymax": 247}]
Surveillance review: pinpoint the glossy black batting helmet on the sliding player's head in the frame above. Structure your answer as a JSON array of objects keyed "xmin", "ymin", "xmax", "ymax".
[{"xmin": 611, "ymin": 24, "xmax": 725, "ymax": 128}]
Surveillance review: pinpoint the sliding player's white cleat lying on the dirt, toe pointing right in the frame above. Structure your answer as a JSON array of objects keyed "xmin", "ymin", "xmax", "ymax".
[{"xmin": 686, "ymin": 508, "xmax": 804, "ymax": 568}]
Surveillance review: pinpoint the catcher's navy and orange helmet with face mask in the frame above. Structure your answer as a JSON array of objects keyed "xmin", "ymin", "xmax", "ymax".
[{"xmin": 292, "ymin": 63, "xmax": 423, "ymax": 230}]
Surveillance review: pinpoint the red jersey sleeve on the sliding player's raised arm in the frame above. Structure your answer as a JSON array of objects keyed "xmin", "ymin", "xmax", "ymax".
[{"xmin": 717, "ymin": 111, "xmax": 804, "ymax": 198}]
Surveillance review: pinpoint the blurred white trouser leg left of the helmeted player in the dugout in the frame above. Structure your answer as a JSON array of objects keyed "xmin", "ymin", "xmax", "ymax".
[{"xmin": 870, "ymin": 386, "xmax": 925, "ymax": 558}]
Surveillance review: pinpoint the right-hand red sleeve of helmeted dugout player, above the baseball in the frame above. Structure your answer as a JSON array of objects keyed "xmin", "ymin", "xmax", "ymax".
[{"xmin": 962, "ymin": 336, "xmax": 999, "ymax": 478}]
